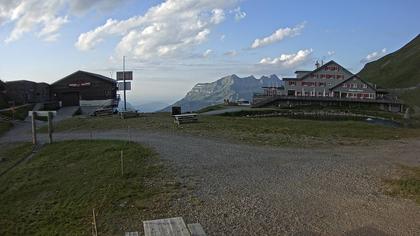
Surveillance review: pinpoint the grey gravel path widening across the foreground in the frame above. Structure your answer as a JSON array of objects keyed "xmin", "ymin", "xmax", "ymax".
[{"xmin": 0, "ymin": 122, "xmax": 420, "ymax": 235}]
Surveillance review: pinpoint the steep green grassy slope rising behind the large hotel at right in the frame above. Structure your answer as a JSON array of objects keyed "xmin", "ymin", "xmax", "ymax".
[{"xmin": 358, "ymin": 35, "xmax": 420, "ymax": 88}]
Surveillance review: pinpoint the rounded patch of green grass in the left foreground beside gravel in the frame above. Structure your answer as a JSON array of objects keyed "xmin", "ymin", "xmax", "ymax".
[{"xmin": 0, "ymin": 141, "xmax": 176, "ymax": 235}]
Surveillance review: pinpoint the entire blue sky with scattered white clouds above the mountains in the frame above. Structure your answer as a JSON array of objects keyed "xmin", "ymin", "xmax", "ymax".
[{"xmin": 0, "ymin": 0, "xmax": 420, "ymax": 107}]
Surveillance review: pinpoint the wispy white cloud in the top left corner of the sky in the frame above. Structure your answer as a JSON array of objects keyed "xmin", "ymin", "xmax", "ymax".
[{"xmin": 0, "ymin": 0, "xmax": 126, "ymax": 43}]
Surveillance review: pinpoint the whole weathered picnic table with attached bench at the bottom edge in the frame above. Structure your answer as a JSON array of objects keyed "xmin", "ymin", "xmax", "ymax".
[{"xmin": 142, "ymin": 217, "xmax": 206, "ymax": 236}]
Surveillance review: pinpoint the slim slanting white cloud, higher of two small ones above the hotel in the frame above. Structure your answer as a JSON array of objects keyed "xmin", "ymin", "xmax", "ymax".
[{"xmin": 251, "ymin": 22, "xmax": 305, "ymax": 48}]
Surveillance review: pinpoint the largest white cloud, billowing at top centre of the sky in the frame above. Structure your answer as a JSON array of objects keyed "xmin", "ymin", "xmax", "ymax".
[{"xmin": 75, "ymin": 0, "xmax": 238, "ymax": 60}]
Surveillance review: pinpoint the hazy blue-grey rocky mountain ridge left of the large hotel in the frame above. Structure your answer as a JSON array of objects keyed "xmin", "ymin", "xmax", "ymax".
[{"xmin": 163, "ymin": 74, "xmax": 283, "ymax": 111}]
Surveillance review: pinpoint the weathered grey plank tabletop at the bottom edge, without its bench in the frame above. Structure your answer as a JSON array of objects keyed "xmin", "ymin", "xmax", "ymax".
[{"xmin": 143, "ymin": 217, "xmax": 191, "ymax": 236}]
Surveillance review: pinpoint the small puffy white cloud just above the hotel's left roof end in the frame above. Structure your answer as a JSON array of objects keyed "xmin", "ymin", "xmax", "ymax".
[{"xmin": 259, "ymin": 49, "xmax": 312, "ymax": 68}]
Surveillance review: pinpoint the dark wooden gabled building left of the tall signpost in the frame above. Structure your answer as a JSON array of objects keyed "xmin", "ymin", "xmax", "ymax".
[{"xmin": 51, "ymin": 71, "xmax": 117, "ymax": 106}]
